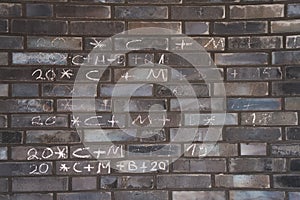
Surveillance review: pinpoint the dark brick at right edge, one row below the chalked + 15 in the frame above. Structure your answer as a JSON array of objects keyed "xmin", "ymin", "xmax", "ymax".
[{"xmin": 272, "ymin": 81, "xmax": 300, "ymax": 96}]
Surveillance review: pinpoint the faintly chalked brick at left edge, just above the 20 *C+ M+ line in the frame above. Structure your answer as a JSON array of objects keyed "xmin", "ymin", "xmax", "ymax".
[{"xmin": 0, "ymin": 99, "xmax": 53, "ymax": 113}]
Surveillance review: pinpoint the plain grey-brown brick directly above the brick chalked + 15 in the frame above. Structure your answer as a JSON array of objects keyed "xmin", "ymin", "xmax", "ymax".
[{"xmin": 215, "ymin": 53, "xmax": 268, "ymax": 65}]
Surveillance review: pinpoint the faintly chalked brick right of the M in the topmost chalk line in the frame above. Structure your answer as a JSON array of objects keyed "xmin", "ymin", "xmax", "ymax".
[{"xmin": 228, "ymin": 36, "xmax": 283, "ymax": 50}]
